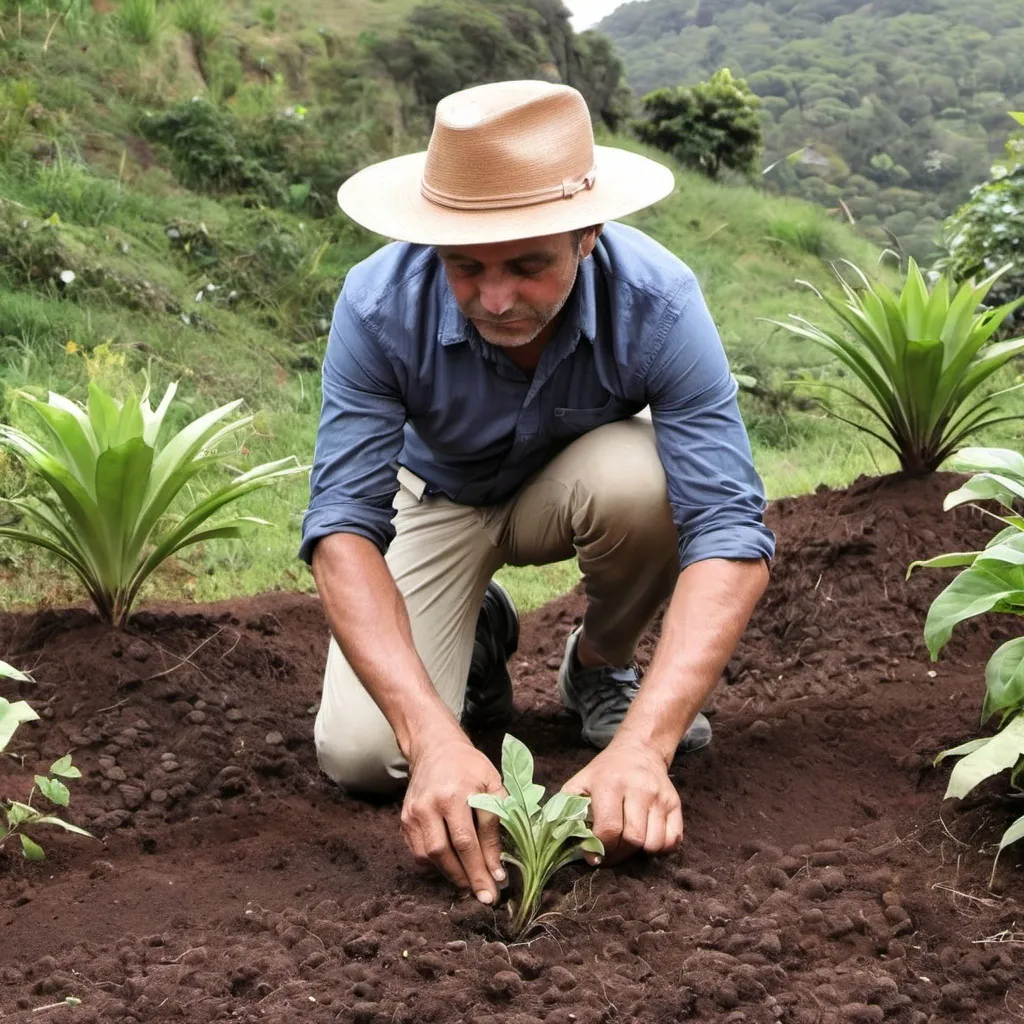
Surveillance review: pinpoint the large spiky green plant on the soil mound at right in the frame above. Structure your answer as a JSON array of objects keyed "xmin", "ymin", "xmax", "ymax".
[{"xmin": 769, "ymin": 259, "xmax": 1024, "ymax": 475}]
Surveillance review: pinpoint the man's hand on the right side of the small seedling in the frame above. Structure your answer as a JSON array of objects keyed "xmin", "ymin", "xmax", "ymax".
[{"xmin": 562, "ymin": 739, "xmax": 683, "ymax": 864}]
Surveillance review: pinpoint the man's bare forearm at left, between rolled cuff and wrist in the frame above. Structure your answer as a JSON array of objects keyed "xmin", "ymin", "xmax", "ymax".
[{"xmin": 312, "ymin": 534, "xmax": 462, "ymax": 759}]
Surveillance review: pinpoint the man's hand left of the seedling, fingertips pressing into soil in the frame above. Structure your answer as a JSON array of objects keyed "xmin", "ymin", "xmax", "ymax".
[{"xmin": 401, "ymin": 733, "xmax": 506, "ymax": 905}]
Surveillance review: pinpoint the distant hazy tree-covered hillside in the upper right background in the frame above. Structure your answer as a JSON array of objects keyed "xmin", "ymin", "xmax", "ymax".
[{"xmin": 597, "ymin": 0, "xmax": 1024, "ymax": 258}]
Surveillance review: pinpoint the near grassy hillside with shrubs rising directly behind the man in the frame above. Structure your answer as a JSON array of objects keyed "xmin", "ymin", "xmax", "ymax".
[{"xmin": 0, "ymin": 5, "xmax": 897, "ymax": 603}]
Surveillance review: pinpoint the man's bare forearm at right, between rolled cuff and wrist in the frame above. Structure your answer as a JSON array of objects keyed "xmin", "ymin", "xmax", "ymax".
[{"xmin": 616, "ymin": 558, "xmax": 768, "ymax": 764}]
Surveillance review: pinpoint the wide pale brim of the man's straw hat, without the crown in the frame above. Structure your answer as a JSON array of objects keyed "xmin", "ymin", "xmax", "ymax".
[{"xmin": 338, "ymin": 145, "xmax": 675, "ymax": 246}]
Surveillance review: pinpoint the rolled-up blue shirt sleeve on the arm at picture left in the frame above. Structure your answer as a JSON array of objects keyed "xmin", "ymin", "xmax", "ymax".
[{"xmin": 299, "ymin": 291, "xmax": 406, "ymax": 563}]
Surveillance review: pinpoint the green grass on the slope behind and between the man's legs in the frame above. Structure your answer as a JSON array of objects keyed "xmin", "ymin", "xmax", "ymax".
[{"xmin": 0, "ymin": 6, "xmax": 1024, "ymax": 608}]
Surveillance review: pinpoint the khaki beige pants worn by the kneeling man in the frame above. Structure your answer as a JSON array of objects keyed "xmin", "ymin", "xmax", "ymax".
[{"xmin": 314, "ymin": 418, "xmax": 679, "ymax": 794}]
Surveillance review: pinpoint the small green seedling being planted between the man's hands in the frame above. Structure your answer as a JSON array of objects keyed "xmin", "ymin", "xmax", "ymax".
[{"xmin": 469, "ymin": 735, "xmax": 604, "ymax": 939}]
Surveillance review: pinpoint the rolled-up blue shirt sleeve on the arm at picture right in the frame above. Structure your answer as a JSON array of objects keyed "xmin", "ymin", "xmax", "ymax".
[{"xmin": 645, "ymin": 279, "xmax": 775, "ymax": 568}]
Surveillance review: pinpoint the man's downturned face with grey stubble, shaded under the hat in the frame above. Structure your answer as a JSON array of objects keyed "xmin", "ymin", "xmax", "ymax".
[{"xmin": 437, "ymin": 229, "xmax": 597, "ymax": 348}]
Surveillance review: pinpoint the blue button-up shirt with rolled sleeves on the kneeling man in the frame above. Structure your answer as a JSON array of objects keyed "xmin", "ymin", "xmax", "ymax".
[{"xmin": 299, "ymin": 223, "xmax": 774, "ymax": 567}]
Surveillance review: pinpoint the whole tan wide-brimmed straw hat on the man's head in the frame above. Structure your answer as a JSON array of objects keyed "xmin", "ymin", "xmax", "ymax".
[{"xmin": 338, "ymin": 82, "xmax": 674, "ymax": 246}]
